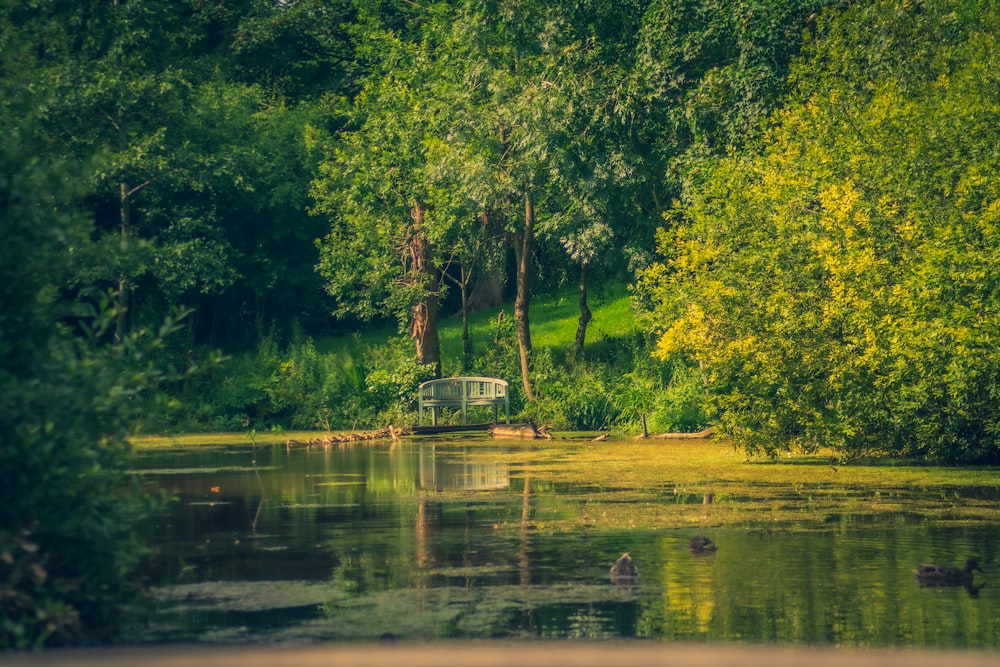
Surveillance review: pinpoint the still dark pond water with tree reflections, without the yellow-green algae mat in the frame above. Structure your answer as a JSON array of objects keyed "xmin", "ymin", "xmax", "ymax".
[{"xmin": 136, "ymin": 439, "xmax": 1000, "ymax": 648}]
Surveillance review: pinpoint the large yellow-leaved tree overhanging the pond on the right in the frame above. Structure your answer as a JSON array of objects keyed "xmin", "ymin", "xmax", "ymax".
[{"xmin": 645, "ymin": 0, "xmax": 1000, "ymax": 461}]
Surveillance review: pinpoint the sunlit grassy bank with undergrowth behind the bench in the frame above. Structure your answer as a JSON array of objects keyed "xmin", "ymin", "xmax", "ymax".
[{"xmin": 162, "ymin": 285, "xmax": 688, "ymax": 434}]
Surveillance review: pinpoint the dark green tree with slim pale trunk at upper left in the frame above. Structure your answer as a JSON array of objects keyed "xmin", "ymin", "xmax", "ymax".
[{"xmin": 7, "ymin": 1, "xmax": 242, "ymax": 341}]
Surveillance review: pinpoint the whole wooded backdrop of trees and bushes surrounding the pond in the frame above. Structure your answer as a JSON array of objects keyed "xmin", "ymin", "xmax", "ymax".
[{"xmin": 0, "ymin": 0, "xmax": 1000, "ymax": 646}]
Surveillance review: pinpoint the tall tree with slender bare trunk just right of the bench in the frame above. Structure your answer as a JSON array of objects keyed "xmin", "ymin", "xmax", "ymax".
[{"xmin": 442, "ymin": 2, "xmax": 636, "ymax": 400}]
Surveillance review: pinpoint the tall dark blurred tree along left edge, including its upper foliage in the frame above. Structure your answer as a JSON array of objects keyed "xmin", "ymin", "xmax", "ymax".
[{"xmin": 0, "ymin": 126, "xmax": 191, "ymax": 648}]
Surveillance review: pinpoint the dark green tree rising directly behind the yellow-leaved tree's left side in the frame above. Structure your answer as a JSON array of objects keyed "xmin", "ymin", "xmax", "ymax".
[{"xmin": 615, "ymin": 0, "xmax": 844, "ymax": 270}]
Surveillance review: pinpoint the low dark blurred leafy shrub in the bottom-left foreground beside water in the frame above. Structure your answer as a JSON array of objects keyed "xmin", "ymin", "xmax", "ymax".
[{"xmin": 0, "ymin": 302, "xmax": 180, "ymax": 648}]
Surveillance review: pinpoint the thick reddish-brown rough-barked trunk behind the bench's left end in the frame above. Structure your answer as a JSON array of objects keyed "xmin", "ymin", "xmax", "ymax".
[{"xmin": 409, "ymin": 204, "xmax": 441, "ymax": 377}]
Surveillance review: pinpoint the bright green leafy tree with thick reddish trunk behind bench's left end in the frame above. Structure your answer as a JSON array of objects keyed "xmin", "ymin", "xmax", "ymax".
[{"xmin": 312, "ymin": 20, "xmax": 458, "ymax": 375}]
